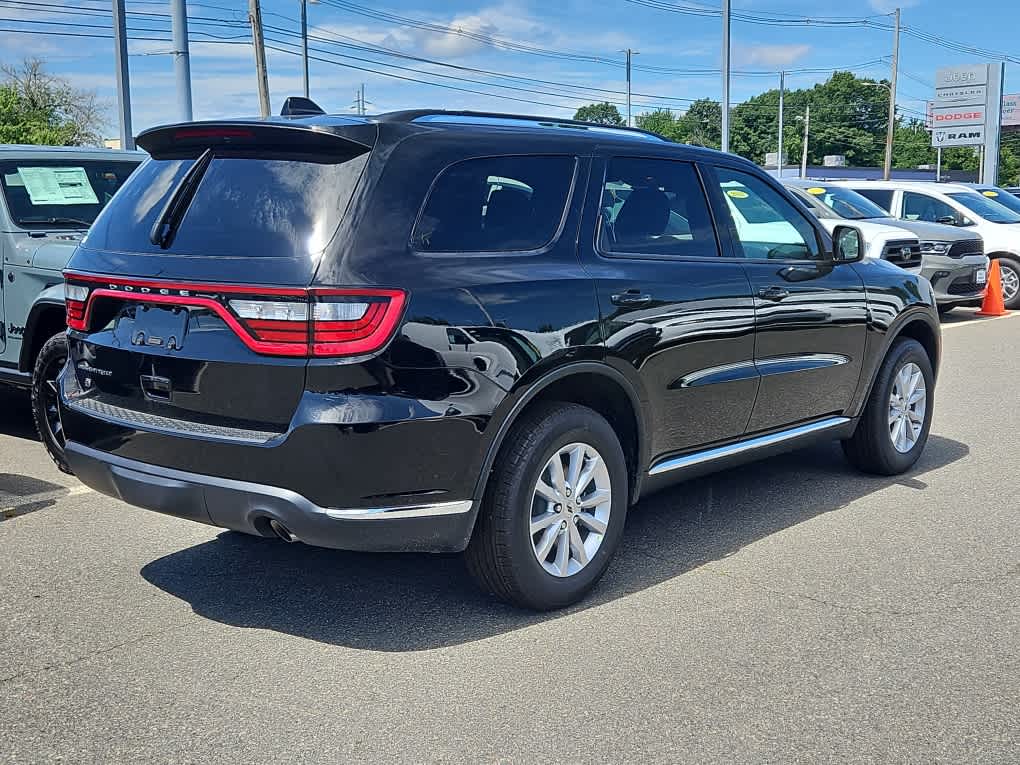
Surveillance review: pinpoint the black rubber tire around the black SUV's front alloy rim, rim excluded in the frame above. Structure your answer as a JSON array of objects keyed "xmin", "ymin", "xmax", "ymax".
[{"xmin": 843, "ymin": 338, "xmax": 934, "ymax": 475}]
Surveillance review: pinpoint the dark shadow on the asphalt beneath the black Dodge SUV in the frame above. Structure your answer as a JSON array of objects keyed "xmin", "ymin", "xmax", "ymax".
[{"xmin": 141, "ymin": 436, "xmax": 969, "ymax": 651}]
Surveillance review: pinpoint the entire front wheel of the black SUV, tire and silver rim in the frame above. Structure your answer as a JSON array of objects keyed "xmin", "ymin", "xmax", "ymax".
[{"xmin": 843, "ymin": 338, "xmax": 935, "ymax": 475}]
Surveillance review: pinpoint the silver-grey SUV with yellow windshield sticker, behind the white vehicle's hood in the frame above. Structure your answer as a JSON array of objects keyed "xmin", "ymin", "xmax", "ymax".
[{"xmin": 783, "ymin": 180, "xmax": 988, "ymax": 313}]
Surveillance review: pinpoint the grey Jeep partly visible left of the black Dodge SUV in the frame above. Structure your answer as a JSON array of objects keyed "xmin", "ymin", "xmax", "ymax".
[{"xmin": 0, "ymin": 146, "xmax": 145, "ymax": 472}]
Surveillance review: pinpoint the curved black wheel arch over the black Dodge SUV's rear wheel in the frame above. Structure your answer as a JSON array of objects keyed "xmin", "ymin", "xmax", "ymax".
[{"xmin": 473, "ymin": 361, "xmax": 648, "ymax": 504}]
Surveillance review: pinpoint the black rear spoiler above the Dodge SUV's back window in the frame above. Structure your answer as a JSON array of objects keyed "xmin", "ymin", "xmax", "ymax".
[{"xmin": 136, "ymin": 119, "xmax": 377, "ymax": 159}]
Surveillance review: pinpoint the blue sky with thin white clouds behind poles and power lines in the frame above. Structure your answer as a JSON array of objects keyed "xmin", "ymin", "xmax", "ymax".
[{"xmin": 0, "ymin": 0, "xmax": 1020, "ymax": 136}]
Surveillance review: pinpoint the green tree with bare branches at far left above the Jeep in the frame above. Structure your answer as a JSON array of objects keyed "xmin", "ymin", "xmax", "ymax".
[{"xmin": 0, "ymin": 59, "xmax": 105, "ymax": 146}]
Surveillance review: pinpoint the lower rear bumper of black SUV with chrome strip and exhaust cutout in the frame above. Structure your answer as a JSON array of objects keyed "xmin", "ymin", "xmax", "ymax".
[{"xmin": 66, "ymin": 442, "xmax": 475, "ymax": 553}]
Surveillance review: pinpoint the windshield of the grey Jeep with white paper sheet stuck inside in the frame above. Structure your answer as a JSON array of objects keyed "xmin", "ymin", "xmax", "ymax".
[{"xmin": 0, "ymin": 157, "xmax": 139, "ymax": 228}]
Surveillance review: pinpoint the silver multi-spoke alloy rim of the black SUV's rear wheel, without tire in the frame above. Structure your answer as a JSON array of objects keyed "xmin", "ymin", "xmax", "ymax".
[{"xmin": 529, "ymin": 443, "xmax": 613, "ymax": 577}]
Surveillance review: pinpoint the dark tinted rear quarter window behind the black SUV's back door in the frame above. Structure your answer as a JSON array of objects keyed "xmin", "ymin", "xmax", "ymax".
[{"xmin": 411, "ymin": 156, "xmax": 576, "ymax": 252}]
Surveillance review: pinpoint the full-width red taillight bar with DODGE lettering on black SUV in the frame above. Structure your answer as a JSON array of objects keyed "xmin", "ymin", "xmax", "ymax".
[{"xmin": 64, "ymin": 273, "xmax": 406, "ymax": 357}]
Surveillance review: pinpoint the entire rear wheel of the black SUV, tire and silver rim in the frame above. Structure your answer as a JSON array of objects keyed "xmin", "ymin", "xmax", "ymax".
[{"xmin": 466, "ymin": 403, "xmax": 628, "ymax": 610}]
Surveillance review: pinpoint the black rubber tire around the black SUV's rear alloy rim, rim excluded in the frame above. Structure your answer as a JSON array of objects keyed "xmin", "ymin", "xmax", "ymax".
[{"xmin": 465, "ymin": 403, "xmax": 629, "ymax": 611}]
